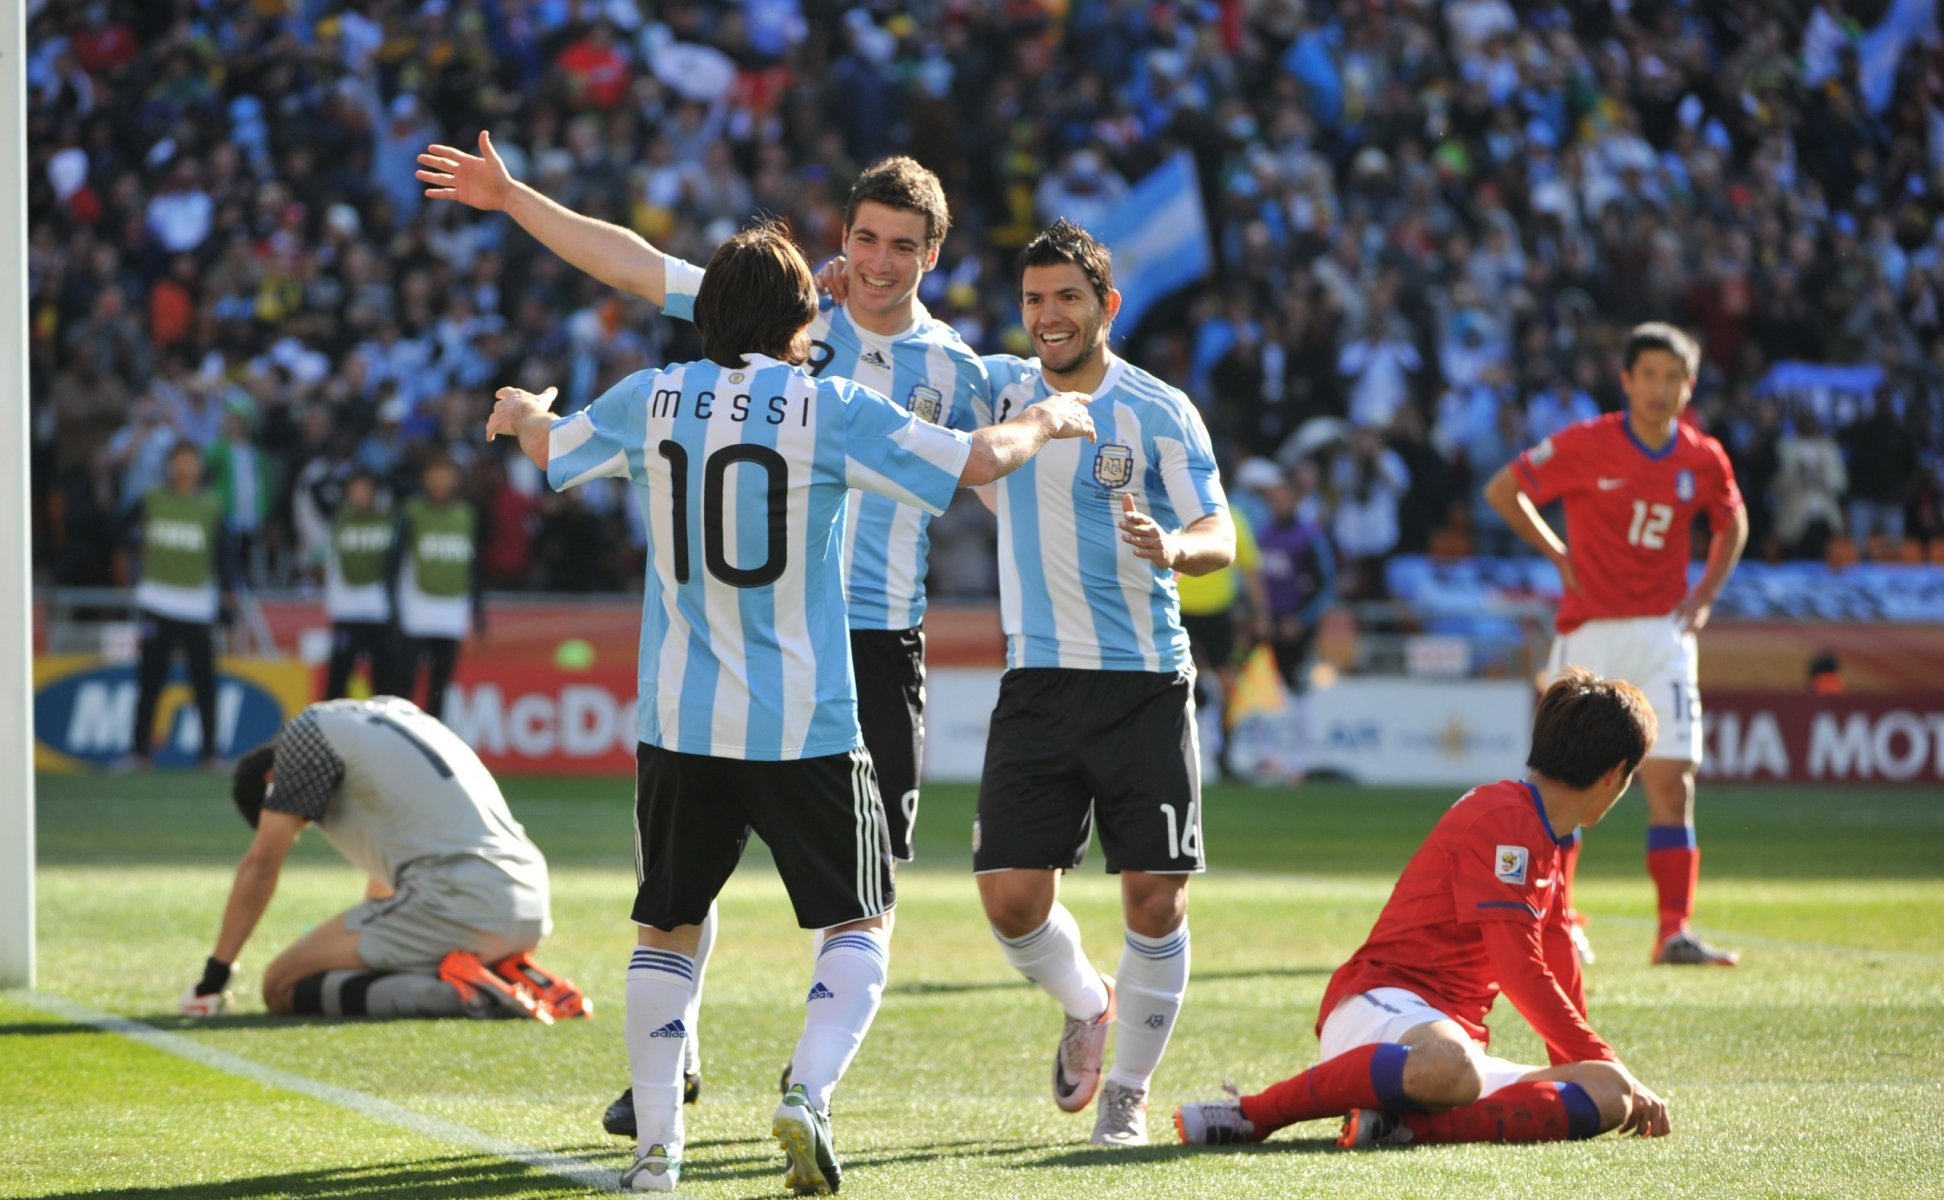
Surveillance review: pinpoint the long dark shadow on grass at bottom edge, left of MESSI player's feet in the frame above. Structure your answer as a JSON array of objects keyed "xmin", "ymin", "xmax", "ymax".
[{"xmin": 20, "ymin": 1155, "xmax": 599, "ymax": 1200}]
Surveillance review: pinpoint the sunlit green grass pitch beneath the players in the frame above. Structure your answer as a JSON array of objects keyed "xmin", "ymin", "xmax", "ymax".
[{"xmin": 0, "ymin": 774, "xmax": 1944, "ymax": 1200}]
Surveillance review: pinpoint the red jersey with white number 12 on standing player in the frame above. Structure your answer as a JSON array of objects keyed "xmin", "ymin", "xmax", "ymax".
[{"xmin": 1514, "ymin": 412, "xmax": 1742, "ymax": 634}]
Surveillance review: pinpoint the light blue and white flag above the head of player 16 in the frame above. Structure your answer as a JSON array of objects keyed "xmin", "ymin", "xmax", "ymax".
[{"xmin": 1093, "ymin": 150, "xmax": 1215, "ymax": 344}]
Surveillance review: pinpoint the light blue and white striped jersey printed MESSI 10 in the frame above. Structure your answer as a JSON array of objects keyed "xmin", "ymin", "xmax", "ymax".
[{"xmin": 546, "ymin": 356, "xmax": 972, "ymax": 760}]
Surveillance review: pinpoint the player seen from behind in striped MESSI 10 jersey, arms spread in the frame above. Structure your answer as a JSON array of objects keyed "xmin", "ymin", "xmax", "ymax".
[{"xmin": 486, "ymin": 226, "xmax": 1093, "ymax": 1194}]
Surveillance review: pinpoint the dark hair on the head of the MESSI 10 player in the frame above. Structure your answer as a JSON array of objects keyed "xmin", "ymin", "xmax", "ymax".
[{"xmin": 696, "ymin": 218, "xmax": 816, "ymax": 368}]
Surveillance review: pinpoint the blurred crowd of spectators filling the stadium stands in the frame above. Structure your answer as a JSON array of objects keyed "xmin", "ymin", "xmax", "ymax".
[{"xmin": 27, "ymin": 0, "xmax": 1944, "ymax": 597}]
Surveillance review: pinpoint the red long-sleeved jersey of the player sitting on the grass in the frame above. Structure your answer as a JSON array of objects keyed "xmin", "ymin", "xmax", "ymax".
[{"xmin": 1316, "ymin": 780, "xmax": 1614, "ymax": 1062}]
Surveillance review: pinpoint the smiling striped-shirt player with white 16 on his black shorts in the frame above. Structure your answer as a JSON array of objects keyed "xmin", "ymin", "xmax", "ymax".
[{"xmin": 972, "ymin": 220, "xmax": 1234, "ymax": 1146}]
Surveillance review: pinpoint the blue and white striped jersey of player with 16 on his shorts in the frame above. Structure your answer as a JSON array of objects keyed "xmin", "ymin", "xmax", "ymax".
[{"xmin": 980, "ymin": 354, "xmax": 1229, "ymax": 673}]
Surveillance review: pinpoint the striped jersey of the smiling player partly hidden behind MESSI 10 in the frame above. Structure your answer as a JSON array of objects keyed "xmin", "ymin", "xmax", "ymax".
[{"xmin": 661, "ymin": 259, "xmax": 991, "ymax": 630}]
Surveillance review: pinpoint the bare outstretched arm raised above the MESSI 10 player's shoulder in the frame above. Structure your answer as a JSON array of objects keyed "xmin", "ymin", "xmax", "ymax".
[{"xmin": 418, "ymin": 130, "xmax": 669, "ymax": 305}]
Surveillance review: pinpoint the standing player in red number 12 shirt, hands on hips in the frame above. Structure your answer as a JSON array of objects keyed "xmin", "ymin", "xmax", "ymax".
[{"xmin": 1485, "ymin": 323, "xmax": 1748, "ymax": 967}]
